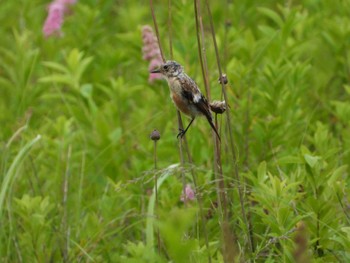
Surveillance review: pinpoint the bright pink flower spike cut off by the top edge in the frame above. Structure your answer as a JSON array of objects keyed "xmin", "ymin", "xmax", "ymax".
[{"xmin": 43, "ymin": 0, "xmax": 77, "ymax": 37}]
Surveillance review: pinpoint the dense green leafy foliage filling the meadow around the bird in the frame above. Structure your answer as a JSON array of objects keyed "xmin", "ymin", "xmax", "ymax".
[{"xmin": 0, "ymin": 0, "xmax": 350, "ymax": 262}]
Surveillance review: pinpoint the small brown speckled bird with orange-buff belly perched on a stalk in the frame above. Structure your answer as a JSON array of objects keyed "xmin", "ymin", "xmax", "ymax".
[{"xmin": 150, "ymin": 60, "xmax": 221, "ymax": 141}]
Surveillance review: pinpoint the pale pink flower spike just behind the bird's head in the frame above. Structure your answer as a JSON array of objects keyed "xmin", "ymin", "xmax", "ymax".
[{"xmin": 142, "ymin": 25, "xmax": 163, "ymax": 83}]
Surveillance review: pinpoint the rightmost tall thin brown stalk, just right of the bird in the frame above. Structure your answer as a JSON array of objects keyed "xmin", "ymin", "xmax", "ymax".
[{"xmin": 205, "ymin": 0, "xmax": 253, "ymax": 252}]
